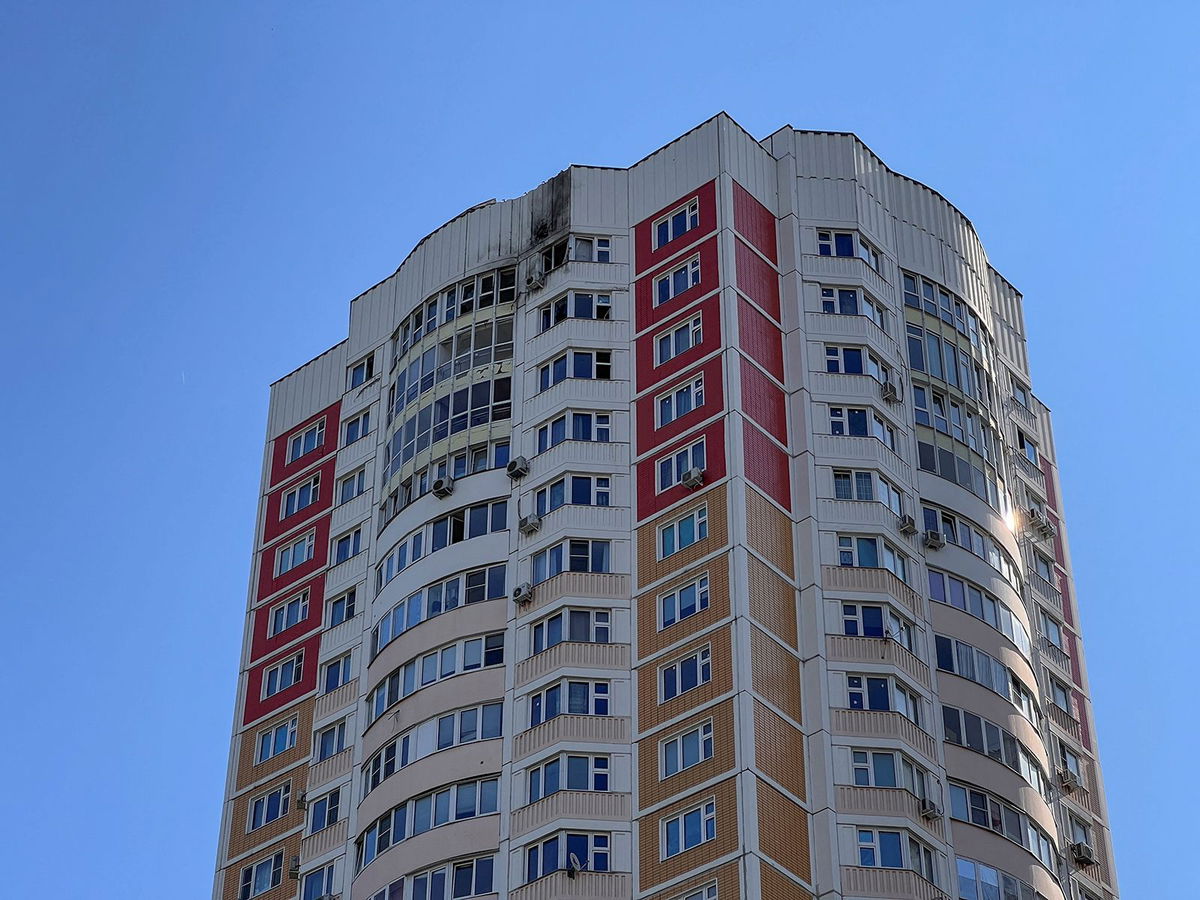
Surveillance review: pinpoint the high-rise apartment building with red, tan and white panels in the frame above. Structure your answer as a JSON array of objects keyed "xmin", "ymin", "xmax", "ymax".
[{"xmin": 214, "ymin": 114, "xmax": 1117, "ymax": 900}]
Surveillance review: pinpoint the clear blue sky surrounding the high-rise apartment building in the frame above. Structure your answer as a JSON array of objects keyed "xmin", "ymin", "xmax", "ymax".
[{"xmin": 0, "ymin": 0, "xmax": 1200, "ymax": 900}]
